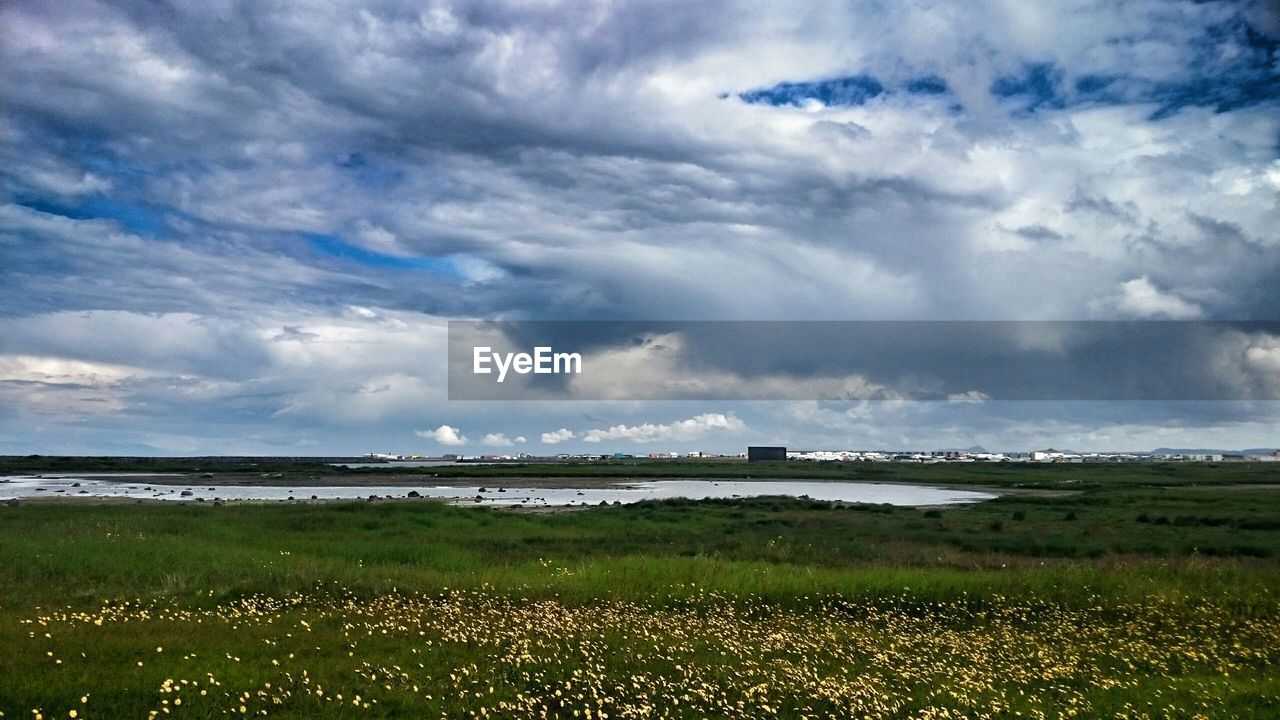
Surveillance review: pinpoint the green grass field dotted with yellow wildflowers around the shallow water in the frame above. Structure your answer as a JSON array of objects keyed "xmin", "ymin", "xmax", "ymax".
[{"xmin": 0, "ymin": 464, "xmax": 1280, "ymax": 717}]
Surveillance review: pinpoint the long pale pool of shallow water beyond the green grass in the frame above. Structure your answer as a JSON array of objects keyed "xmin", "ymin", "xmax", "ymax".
[{"xmin": 0, "ymin": 475, "xmax": 996, "ymax": 507}]
